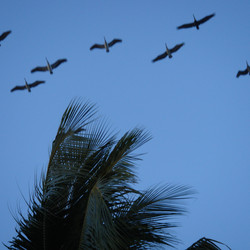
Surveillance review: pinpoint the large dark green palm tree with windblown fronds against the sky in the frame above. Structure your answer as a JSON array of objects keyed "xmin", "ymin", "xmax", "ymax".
[{"xmin": 6, "ymin": 100, "xmax": 194, "ymax": 250}]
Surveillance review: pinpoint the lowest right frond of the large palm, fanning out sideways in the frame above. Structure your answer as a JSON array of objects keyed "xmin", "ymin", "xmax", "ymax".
[{"xmin": 116, "ymin": 185, "xmax": 194, "ymax": 249}]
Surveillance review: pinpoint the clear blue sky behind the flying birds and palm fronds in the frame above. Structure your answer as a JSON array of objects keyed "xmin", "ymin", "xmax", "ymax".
[{"xmin": 0, "ymin": 0, "xmax": 250, "ymax": 249}]
